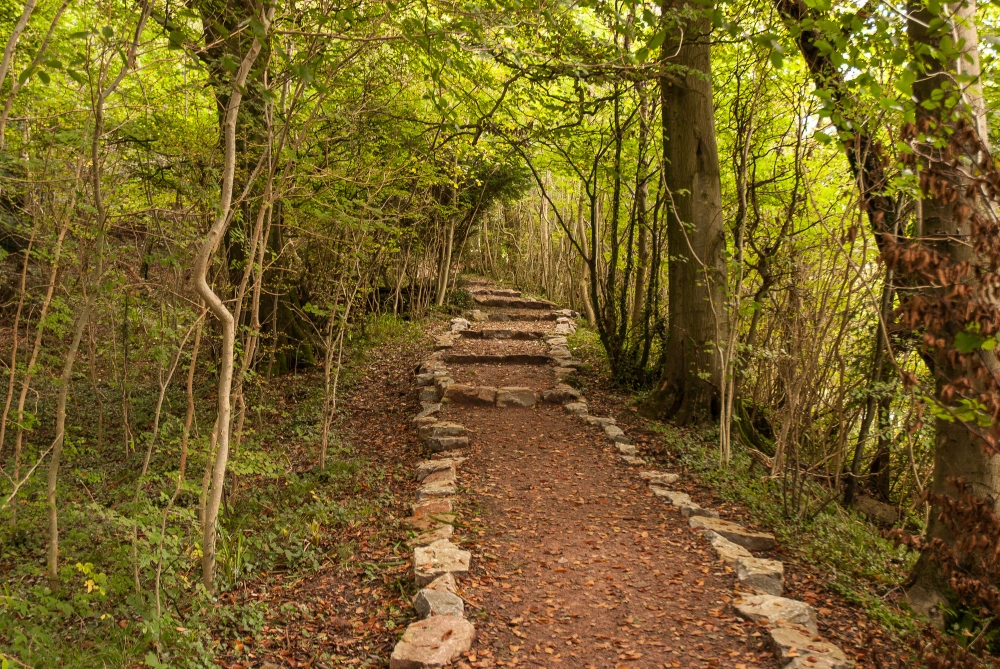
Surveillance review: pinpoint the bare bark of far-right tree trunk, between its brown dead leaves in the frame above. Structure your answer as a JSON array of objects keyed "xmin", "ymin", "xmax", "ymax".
[{"xmin": 907, "ymin": 0, "xmax": 1000, "ymax": 622}]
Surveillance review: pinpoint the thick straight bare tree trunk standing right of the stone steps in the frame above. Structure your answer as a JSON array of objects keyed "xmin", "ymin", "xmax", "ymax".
[{"xmin": 653, "ymin": 3, "xmax": 729, "ymax": 423}]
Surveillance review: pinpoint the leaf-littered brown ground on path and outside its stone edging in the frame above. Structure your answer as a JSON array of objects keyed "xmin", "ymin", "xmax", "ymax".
[{"xmin": 209, "ymin": 282, "xmax": 916, "ymax": 669}]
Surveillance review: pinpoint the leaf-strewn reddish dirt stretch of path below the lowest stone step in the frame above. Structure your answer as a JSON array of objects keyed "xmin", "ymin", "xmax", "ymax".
[{"xmin": 447, "ymin": 406, "xmax": 777, "ymax": 668}]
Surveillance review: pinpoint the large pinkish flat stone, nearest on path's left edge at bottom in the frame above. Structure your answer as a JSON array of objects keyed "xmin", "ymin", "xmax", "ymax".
[{"xmin": 389, "ymin": 616, "xmax": 476, "ymax": 669}]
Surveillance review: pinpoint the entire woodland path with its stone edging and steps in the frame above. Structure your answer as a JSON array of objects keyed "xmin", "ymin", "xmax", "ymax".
[{"xmin": 390, "ymin": 284, "xmax": 850, "ymax": 669}]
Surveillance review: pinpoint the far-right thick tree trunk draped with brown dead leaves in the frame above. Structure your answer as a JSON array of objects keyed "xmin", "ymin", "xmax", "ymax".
[{"xmin": 891, "ymin": 0, "xmax": 1000, "ymax": 623}]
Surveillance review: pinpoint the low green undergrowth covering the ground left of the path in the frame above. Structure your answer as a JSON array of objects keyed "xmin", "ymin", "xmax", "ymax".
[{"xmin": 0, "ymin": 317, "xmax": 420, "ymax": 669}]
